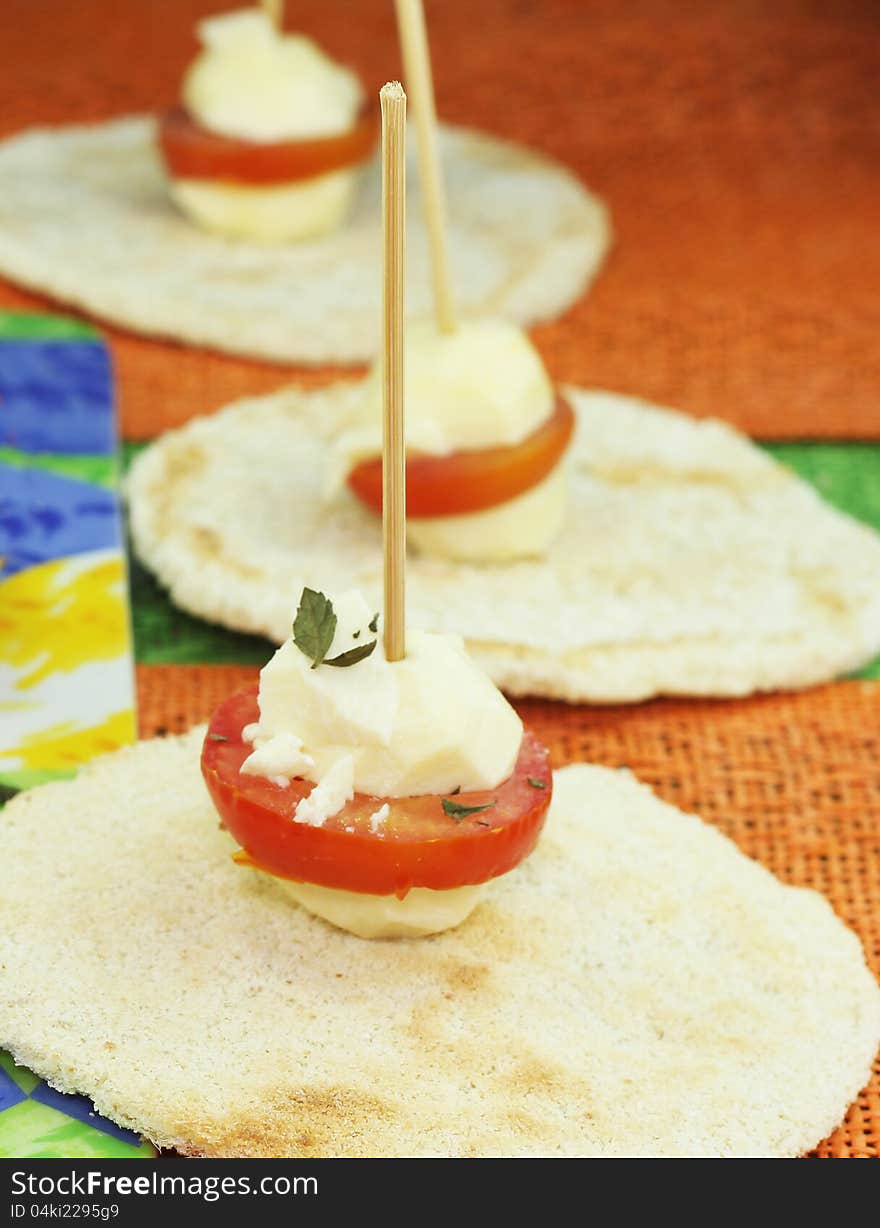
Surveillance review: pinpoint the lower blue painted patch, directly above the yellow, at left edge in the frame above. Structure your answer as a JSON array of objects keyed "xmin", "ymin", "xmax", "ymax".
[{"xmin": 0, "ymin": 461, "xmax": 122, "ymax": 577}]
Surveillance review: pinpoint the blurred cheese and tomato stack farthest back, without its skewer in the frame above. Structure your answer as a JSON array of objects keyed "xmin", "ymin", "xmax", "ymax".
[{"xmin": 160, "ymin": 9, "xmax": 377, "ymax": 241}]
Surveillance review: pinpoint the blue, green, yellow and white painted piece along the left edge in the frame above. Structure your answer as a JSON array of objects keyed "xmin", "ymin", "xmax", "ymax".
[{"xmin": 0, "ymin": 313, "xmax": 155, "ymax": 1158}]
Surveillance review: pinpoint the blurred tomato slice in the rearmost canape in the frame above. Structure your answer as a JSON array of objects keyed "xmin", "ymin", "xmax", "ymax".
[{"xmin": 158, "ymin": 107, "xmax": 377, "ymax": 184}]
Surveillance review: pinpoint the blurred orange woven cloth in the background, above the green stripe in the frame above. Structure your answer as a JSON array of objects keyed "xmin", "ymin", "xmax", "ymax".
[{"xmin": 0, "ymin": 0, "xmax": 880, "ymax": 438}]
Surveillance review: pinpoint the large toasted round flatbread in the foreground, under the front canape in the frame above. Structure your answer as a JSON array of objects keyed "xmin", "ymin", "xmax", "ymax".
[{"xmin": 0, "ymin": 731, "xmax": 880, "ymax": 1157}]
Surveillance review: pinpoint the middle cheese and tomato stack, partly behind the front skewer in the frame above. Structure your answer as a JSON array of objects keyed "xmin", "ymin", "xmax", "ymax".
[{"xmin": 333, "ymin": 319, "xmax": 574, "ymax": 562}]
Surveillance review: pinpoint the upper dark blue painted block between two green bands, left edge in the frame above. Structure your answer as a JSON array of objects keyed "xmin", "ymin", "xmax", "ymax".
[{"xmin": 0, "ymin": 340, "xmax": 115, "ymax": 456}]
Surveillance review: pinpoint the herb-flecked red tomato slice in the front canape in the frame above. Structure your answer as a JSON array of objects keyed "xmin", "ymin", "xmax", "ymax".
[{"xmin": 201, "ymin": 686, "xmax": 554, "ymax": 898}]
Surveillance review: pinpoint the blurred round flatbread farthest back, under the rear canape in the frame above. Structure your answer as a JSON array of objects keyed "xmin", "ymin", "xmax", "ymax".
[{"xmin": 0, "ymin": 117, "xmax": 610, "ymax": 362}]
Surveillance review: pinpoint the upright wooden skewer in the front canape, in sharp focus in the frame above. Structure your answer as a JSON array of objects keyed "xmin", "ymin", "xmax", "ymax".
[{"xmin": 379, "ymin": 81, "xmax": 406, "ymax": 661}]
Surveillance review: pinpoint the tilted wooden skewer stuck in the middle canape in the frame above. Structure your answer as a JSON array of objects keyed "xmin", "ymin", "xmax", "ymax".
[{"xmin": 395, "ymin": 0, "xmax": 455, "ymax": 333}]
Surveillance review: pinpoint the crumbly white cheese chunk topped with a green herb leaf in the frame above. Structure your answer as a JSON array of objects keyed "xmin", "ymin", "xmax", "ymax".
[{"xmin": 243, "ymin": 592, "xmax": 523, "ymax": 795}]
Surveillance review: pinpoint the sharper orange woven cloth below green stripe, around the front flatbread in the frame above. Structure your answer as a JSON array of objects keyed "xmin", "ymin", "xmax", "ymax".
[{"xmin": 137, "ymin": 666, "xmax": 880, "ymax": 1158}]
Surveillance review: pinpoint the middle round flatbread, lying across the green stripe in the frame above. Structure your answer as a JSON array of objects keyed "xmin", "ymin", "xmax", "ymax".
[{"xmin": 129, "ymin": 383, "xmax": 880, "ymax": 701}]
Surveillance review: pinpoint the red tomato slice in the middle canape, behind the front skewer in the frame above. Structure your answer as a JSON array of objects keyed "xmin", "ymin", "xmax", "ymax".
[{"xmin": 347, "ymin": 397, "xmax": 574, "ymax": 516}]
